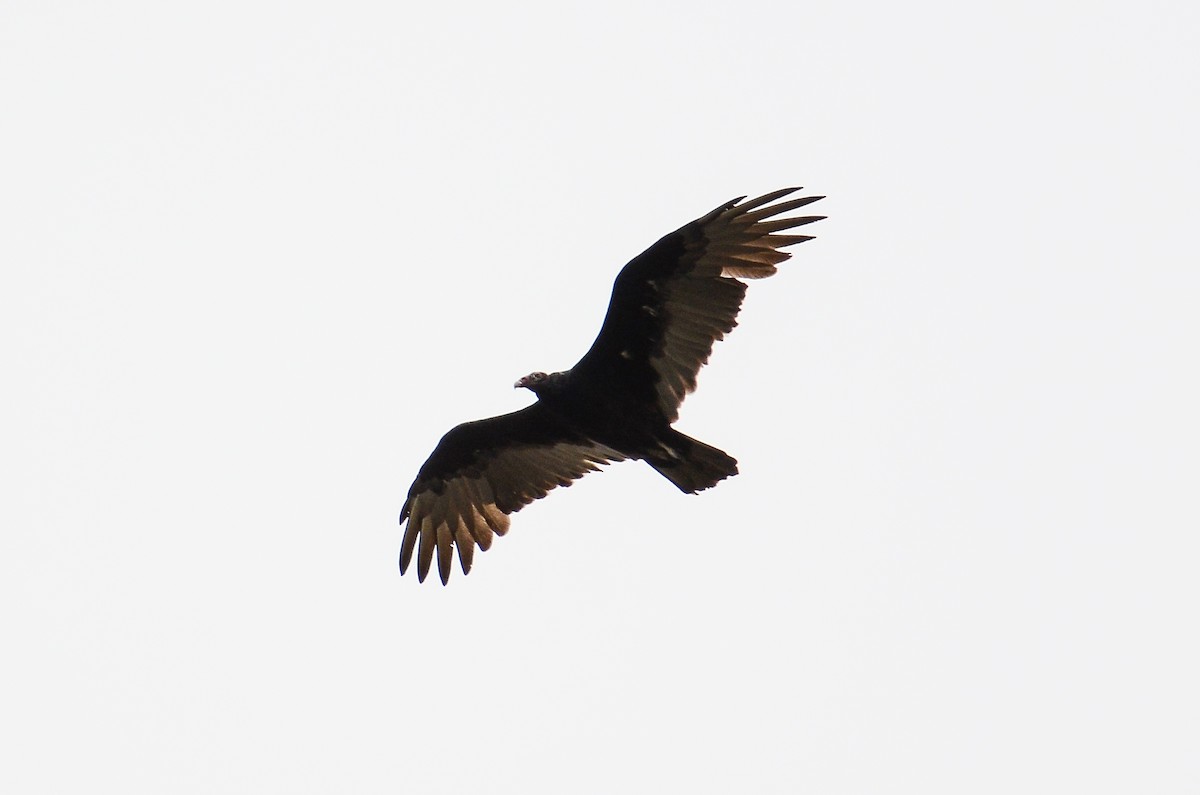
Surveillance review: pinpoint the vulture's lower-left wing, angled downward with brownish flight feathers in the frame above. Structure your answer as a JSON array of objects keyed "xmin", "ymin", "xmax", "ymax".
[{"xmin": 400, "ymin": 404, "xmax": 625, "ymax": 585}]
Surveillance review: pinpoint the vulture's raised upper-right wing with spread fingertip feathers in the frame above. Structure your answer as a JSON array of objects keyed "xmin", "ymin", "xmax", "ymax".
[{"xmin": 571, "ymin": 187, "xmax": 824, "ymax": 423}]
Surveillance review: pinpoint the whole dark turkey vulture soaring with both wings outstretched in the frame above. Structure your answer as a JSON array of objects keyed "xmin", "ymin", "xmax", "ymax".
[{"xmin": 400, "ymin": 187, "xmax": 824, "ymax": 585}]
